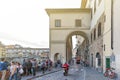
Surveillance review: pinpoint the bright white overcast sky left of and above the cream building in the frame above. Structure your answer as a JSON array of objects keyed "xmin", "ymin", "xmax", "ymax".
[{"xmin": 0, "ymin": 0, "xmax": 81, "ymax": 48}]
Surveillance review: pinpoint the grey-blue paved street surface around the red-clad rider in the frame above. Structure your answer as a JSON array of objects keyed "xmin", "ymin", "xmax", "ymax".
[{"xmin": 32, "ymin": 65, "xmax": 114, "ymax": 80}]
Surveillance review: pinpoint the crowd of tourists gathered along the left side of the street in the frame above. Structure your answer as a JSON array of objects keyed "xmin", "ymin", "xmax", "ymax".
[{"xmin": 0, "ymin": 58, "xmax": 53, "ymax": 80}]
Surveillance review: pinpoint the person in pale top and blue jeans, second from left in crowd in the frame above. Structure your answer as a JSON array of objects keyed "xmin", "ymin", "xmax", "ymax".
[{"xmin": 9, "ymin": 61, "xmax": 17, "ymax": 80}]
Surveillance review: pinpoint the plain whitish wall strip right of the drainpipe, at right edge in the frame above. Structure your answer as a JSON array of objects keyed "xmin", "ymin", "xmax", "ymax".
[{"xmin": 112, "ymin": 0, "xmax": 120, "ymax": 79}]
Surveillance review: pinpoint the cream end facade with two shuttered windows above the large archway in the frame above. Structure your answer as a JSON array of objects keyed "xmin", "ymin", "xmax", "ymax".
[{"xmin": 46, "ymin": 8, "xmax": 91, "ymax": 62}]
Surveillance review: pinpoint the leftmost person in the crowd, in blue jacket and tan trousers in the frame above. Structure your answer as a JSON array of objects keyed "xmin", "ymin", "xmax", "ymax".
[{"xmin": 0, "ymin": 58, "xmax": 7, "ymax": 80}]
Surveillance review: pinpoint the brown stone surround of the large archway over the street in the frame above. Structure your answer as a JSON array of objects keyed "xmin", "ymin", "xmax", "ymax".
[{"xmin": 66, "ymin": 31, "xmax": 89, "ymax": 61}]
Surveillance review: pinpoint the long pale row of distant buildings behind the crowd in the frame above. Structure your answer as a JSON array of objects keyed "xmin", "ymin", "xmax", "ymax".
[{"xmin": 6, "ymin": 45, "xmax": 49, "ymax": 61}]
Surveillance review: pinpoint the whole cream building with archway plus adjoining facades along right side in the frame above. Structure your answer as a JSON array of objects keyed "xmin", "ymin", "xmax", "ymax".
[{"xmin": 46, "ymin": 0, "xmax": 120, "ymax": 78}]
